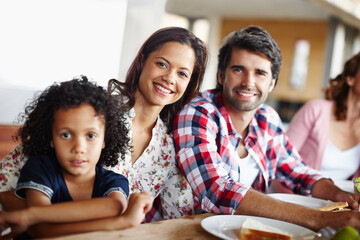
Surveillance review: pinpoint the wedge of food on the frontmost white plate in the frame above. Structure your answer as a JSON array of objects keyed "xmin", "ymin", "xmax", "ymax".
[{"xmin": 239, "ymin": 218, "xmax": 292, "ymax": 240}]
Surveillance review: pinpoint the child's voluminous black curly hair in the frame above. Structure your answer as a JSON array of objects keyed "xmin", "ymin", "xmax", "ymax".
[{"xmin": 16, "ymin": 76, "xmax": 129, "ymax": 166}]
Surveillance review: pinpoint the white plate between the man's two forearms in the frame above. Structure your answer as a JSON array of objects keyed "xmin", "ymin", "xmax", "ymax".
[{"xmin": 267, "ymin": 193, "xmax": 327, "ymax": 209}]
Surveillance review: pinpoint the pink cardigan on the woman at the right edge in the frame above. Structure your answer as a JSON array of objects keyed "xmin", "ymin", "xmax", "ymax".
[{"xmin": 287, "ymin": 99, "xmax": 360, "ymax": 177}]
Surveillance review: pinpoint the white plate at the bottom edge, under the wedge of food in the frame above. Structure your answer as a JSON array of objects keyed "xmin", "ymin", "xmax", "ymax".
[{"xmin": 201, "ymin": 215, "xmax": 315, "ymax": 240}]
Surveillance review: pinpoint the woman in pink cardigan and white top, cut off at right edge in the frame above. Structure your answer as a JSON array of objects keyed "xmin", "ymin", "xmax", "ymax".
[{"xmin": 287, "ymin": 53, "xmax": 360, "ymax": 180}]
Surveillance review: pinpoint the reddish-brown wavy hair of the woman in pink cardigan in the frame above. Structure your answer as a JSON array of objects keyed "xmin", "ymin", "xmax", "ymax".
[{"xmin": 324, "ymin": 53, "xmax": 360, "ymax": 121}]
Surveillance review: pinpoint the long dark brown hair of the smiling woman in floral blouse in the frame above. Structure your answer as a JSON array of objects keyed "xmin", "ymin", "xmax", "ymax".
[{"xmin": 108, "ymin": 27, "xmax": 208, "ymax": 132}]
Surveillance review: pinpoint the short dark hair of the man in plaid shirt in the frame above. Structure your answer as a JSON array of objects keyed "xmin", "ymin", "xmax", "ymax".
[{"xmin": 216, "ymin": 26, "xmax": 282, "ymax": 90}]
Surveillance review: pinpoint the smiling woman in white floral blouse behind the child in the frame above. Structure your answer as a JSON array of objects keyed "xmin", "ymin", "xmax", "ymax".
[{"xmin": 0, "ymin": 27, "xmax": 207, "ymax": 222}]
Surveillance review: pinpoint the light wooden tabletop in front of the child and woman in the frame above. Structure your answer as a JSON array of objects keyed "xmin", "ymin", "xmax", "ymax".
[{"xmin": 49, "ymin": 213, "xmax": 219, "ymax": 240}]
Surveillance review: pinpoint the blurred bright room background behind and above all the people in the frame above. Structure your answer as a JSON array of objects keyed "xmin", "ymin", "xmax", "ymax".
[{"xmin": 0, "ymin": 0, "xmax": 360, "ymax": 156}]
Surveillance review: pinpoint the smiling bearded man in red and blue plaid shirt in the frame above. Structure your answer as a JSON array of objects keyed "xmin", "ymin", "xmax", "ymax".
[{"xmin": 174, "ymin": 26, "xmax": 360, "ymax": 231}]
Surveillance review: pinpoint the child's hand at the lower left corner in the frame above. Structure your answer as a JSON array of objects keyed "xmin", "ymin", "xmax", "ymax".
[{"xmin": 0, "ymin": 210, "xmax": 29, "ymax": 239}]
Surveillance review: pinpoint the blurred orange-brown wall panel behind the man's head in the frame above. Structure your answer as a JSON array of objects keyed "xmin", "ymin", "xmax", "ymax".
[{"xmin": 221, "ymin": 19, "xmax": 328, "ymax": 102}]
